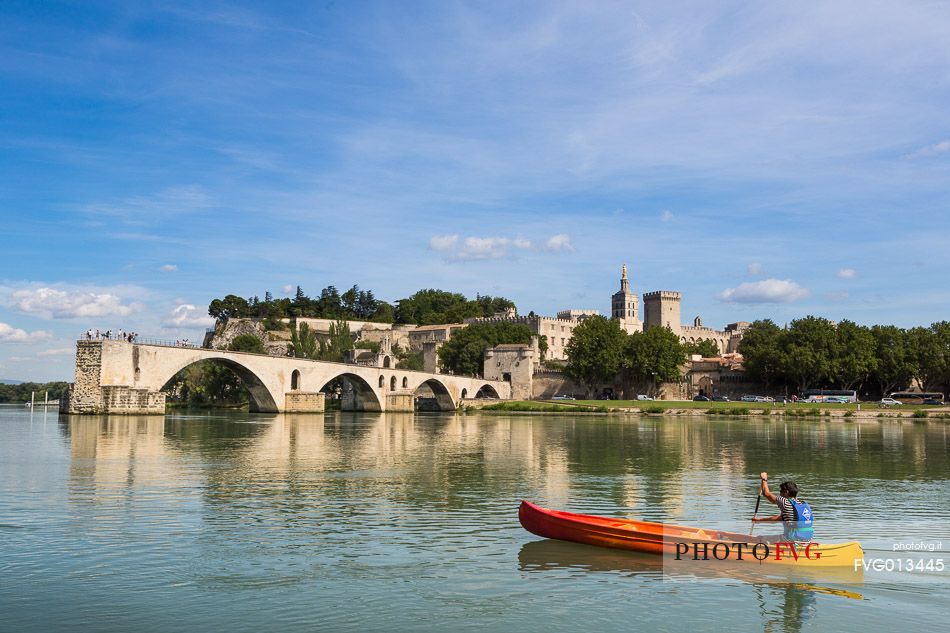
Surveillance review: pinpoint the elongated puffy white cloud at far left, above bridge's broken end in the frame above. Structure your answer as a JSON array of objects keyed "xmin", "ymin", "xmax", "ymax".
[{"xmin": 10, "ymin": 286, "xmax": 145, "ymax": 319}]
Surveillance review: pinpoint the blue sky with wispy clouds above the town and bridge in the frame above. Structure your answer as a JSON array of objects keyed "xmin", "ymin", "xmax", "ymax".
[{"xmin": 0, "ymin": 0, "xmax": 950, "ymax": 380}]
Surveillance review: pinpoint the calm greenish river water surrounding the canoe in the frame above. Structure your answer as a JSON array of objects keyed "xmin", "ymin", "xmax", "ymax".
[{"xmin": 0, "ymin": 406, "xmax": 950, "ymax": 632}]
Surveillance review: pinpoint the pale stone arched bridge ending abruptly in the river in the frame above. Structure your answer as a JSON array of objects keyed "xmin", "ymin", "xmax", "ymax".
[{"xmin": 60, "ymin": 340, "xmax": 511, "ymax": 414}]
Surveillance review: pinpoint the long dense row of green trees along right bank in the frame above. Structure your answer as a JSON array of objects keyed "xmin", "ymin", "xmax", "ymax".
[{"xmin": 739, "ymin": 316, "xmax": 950, "ymax": 396}]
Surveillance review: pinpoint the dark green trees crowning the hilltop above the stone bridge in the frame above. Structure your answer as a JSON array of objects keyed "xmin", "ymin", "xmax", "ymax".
[{"xmin": 208, "ymin": 285, "xmax": 515, "ymax": 329}]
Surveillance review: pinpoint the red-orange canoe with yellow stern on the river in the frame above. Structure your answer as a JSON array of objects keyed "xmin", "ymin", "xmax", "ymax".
[{"xmin": 518, "ymin": 501, "xmax": 864, "ymax": 568}]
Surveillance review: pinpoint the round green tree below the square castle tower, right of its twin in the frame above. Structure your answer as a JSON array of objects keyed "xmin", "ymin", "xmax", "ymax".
[{"xmin": 622, "ymin": 327, "xmax": 686, "ymax": 394}]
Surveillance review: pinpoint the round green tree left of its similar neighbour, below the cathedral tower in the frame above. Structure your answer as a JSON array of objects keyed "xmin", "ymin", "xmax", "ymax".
[{"xmin": 564, "ymin": 316, "xmax": 627, "ymax": 396}]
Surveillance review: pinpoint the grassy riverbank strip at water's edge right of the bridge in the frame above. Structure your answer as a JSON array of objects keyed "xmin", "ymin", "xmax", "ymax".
[{"xmin": 470, "ymin": 400, "xmax": 950, "ymax": 420}]
